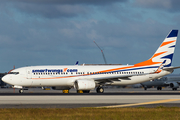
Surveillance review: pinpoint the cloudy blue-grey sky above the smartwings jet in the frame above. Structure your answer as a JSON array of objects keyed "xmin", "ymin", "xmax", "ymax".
[{"xmin": 0, "ymin": 0, "xmax": 180, "ymax": 73}]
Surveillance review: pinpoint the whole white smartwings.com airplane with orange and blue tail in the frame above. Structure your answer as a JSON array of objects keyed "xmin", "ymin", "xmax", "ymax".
[{"xmin": 2, "ymin": 30, "xmax": 180, "ymax": 93}]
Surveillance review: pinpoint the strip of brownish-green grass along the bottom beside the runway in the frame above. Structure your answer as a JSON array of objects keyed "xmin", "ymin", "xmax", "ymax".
[{"xmin": 0, "ymin": 106, "xmax": 180, "ymax": 120}]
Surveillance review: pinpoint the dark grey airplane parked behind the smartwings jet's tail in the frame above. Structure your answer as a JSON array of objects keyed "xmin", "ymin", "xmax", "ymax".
[{"xmin": 141, "ymin": 74, "xmax": 180, "ymax": 90}]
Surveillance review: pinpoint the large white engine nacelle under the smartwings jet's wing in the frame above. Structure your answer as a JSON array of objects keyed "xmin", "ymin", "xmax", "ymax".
[{"xmin": 74, "ymin": 80, "xmax": 96, "ymax": 90}]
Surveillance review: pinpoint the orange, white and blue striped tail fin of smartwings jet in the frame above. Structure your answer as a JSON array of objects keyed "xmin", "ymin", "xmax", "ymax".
[{"xmin": 135, "ymin": 30, "xmax": 178, "ymax": 67}]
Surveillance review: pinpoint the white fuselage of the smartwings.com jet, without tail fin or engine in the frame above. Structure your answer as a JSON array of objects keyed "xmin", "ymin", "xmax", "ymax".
[{"xmin": 2, "ymin": 65, "xmax": 172, "ymax": 87}]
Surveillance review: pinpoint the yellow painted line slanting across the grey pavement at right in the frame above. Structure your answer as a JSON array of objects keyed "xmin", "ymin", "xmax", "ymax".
[{"xmin": 97, "ymin": 99, "xmax": 180, "ymax": 108}]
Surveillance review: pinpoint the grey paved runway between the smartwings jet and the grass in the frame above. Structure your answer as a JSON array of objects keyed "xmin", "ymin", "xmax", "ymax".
[{"xmin": 0, "ymin": 88, "xmax": 180, "ymax": 108}]
